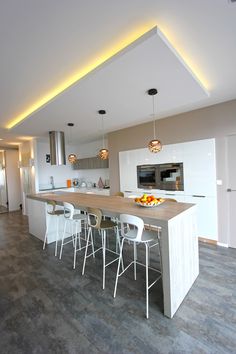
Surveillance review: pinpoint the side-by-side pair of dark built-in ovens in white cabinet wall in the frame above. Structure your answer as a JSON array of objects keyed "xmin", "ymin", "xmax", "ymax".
[{"xmin": 137, "ymin": 162, "xmax": 184, "ymax": 191}]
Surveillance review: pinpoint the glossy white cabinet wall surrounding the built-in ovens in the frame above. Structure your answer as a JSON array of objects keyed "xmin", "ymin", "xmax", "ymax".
[{"xmin": 119, "ymin": 139, "xmax": 218, "ymax": 240}]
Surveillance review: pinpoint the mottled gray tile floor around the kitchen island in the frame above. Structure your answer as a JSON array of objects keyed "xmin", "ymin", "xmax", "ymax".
[{"xmin": 0, "ymin": 212, "xmax": 236, "ymax": 354}]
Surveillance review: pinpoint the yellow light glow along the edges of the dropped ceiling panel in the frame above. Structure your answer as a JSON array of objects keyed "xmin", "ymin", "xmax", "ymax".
[{"xmin": 6, "ymin": 23, "xmax": 209, "ymax": 129}]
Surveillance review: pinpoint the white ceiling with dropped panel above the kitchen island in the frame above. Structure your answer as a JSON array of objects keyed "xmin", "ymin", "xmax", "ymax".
[{"xmin": 0, "ymin": 0, "xmax": 236, "ymax": 146}]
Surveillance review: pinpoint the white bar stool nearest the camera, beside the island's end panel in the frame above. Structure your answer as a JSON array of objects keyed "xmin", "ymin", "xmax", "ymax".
[{"xmin": 114, "ymin": 214, "xmax": 162, "ymax": 318}]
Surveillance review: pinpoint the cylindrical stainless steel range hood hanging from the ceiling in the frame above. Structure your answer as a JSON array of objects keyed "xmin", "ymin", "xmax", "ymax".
[{"xmin": 49, "ymin": 131, "xmax": 66, "ymax": 165}]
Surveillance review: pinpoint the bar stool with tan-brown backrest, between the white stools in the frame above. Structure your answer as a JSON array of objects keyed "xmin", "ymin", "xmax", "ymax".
[{"xmin": 82, "ymin": 208, "xmax": 120, "ymax": 289}]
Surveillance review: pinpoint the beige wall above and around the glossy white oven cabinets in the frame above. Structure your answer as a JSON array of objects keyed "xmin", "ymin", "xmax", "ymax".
[{"xmin": 108, "ymin": 100, "xmax": 236, "ymax": 243}]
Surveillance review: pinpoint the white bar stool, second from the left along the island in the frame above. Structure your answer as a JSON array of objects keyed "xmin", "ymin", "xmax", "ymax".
[{"xmin": 59, "ymin": 202, "xmax": 88, "ymax": 269}]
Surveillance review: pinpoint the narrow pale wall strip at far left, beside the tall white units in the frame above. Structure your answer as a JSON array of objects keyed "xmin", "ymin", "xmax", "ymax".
[{"xmin": 6, "ymin": 150, "xmax": 22, "ymax": 211}]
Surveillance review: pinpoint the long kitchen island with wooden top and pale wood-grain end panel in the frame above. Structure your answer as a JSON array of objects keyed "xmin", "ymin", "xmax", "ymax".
[{"xmin": 28, "ymin": 192, "xmax": 199, "ymax": 318}]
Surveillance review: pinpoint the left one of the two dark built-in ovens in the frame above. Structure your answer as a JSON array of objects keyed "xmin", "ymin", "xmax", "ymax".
[{"xmin": 137, "ymin": 165, "xmax": 157, "ymax": 188}]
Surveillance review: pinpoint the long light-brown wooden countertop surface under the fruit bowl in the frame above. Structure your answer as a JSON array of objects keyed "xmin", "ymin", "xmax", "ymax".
[{"xmin": 27, "ymin": 191, "xmax": 194, "ymax": 221}]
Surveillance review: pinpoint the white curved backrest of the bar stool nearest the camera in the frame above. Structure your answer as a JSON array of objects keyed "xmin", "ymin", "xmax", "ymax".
[{"xmin": 120, "ymin": 214, "xmax": 144, "ymax": 242}]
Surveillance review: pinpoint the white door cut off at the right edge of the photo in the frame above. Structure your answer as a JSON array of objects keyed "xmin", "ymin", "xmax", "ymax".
[{"xmin": 227, "ymin": 135, "xmax": 236, "ymax": 248}]
